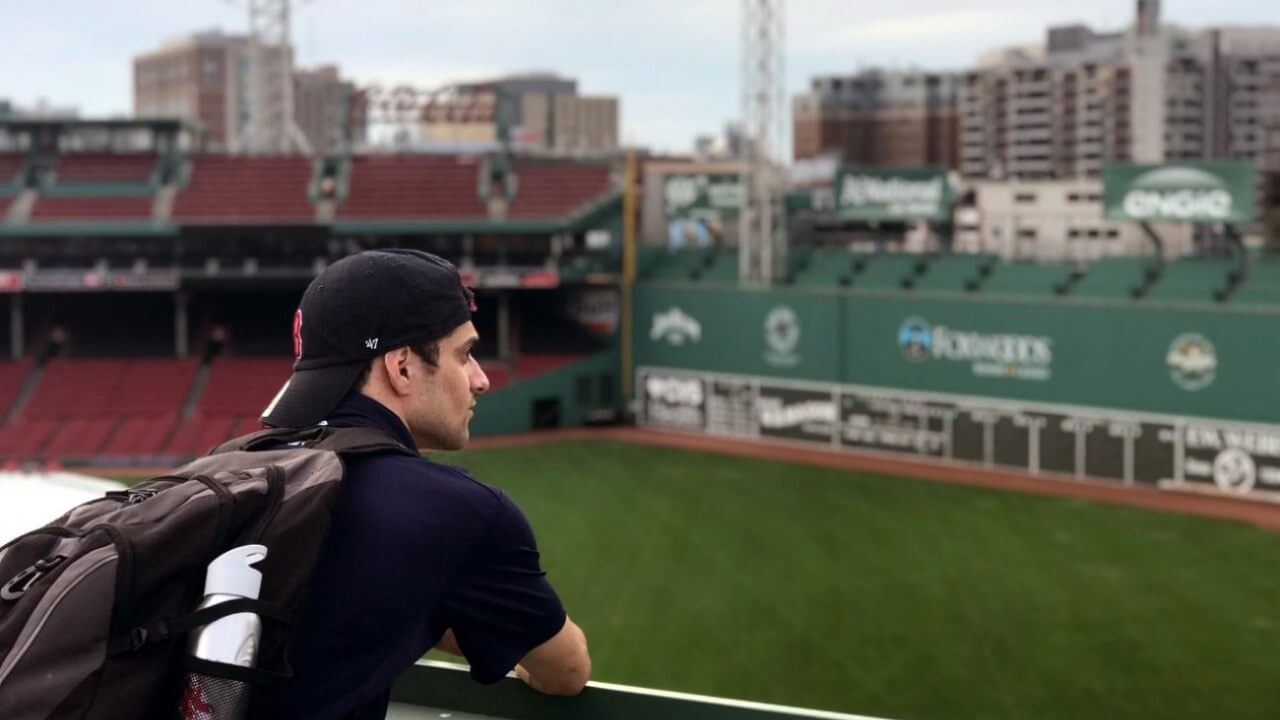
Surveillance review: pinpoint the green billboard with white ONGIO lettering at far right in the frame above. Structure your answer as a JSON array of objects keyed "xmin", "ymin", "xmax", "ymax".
[{"xmin": 1102, "ymin": 160, "xmax": 1258, "ymax": 223}]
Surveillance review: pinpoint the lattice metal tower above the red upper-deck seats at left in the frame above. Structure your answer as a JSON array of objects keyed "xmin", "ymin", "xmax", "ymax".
[{"xmin": 246, "ymin": 0, "xmax": 311, "ymax": 152}]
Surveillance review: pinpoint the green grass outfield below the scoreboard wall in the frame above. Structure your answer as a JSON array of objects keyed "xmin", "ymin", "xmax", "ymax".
[{"xmin": 440, "ymin": 442, "xmax": 1280, "ymax": 720}]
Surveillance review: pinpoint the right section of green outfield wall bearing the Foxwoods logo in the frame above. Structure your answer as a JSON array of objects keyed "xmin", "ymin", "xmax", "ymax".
[{"xmin": 842, "ymin": 297, "xmax": 1280, "ymax": 423}]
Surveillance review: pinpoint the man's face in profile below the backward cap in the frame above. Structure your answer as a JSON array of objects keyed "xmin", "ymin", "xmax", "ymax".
[{"xmin": 406, "ymin": 322, "xmax": 489, "ymax": 450}]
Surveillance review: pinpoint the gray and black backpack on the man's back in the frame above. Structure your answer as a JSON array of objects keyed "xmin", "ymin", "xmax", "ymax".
[{"xmin": 0, "ymin": 427, "xmax": 410, "ymax": 720}]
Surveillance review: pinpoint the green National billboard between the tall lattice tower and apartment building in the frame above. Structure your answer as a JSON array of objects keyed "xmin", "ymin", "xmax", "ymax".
[{"xmin": 836, "ymin": 168, "xmax": 952, "ymax": 222}]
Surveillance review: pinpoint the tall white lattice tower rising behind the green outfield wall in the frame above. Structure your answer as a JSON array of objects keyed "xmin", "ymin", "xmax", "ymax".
[{"xmin": 739, "ymin": 0, "xmax": 787, "ymax": 283}]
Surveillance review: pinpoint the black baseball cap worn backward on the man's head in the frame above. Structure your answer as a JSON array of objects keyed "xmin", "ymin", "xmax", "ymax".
[{"xmin": 262, "ymin": 249, "xmax": 475, "ymax": 428}]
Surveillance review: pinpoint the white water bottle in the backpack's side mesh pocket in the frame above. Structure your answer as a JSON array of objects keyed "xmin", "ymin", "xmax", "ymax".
[{"xmin": 179, "ymin": 544, "xmax": 266, "ymax": 720}]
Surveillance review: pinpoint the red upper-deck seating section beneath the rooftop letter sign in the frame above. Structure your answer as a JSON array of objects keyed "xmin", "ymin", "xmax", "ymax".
[{"xmin": 337, "ymin": 155, "xmax": 488, "ymax": 219}]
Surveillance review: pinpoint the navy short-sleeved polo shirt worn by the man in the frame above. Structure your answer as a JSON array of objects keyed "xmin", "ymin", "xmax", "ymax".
[{"xmin": 273, "ymin": 393, "xmax": 566, "ymax": 720}]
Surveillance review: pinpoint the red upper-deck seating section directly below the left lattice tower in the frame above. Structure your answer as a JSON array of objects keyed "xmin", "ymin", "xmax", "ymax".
[{"xmin": 173, "ymin": 155, "xmax": 316, "ymax": 223}]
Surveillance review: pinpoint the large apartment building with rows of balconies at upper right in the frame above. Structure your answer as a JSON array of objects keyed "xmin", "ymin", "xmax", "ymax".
[{"xmin": 959, "ymin": 0, "xmax": 1280, "ymax": 179}]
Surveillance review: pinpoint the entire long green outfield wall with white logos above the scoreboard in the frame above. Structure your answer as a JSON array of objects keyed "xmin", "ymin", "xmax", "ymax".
[{"xmin": 635, "ymin": 283, "xmax": 1280, "ymax": 423}]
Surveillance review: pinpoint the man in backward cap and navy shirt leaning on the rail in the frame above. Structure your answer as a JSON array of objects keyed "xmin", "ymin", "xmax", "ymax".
[{"xmin": 262, "ymin": 250, "xmax": 591, "ymax": 720}]
